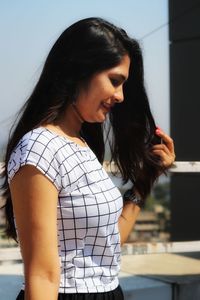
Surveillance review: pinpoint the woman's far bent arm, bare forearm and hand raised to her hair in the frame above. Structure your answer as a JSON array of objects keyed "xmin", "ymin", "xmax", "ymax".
[{"xmin": 118, "ymin": 128, "xmax": 175, "ymax": 244}]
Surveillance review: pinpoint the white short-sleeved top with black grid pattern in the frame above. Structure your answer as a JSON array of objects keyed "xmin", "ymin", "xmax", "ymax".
[{"xmin": 8, "ymin": 127, "xmax": 122, "ymax": 293}]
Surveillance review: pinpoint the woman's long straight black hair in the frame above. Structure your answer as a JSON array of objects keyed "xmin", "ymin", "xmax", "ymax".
[{"xmin": 2, "ymin": 18, "xmax": 162, "ymax": 239}]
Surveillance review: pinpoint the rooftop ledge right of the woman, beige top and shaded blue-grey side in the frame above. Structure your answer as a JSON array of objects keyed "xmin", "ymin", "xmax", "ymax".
[{"xmin": 120, "ymin": 241, "xmax": 200, "ymax": 300}]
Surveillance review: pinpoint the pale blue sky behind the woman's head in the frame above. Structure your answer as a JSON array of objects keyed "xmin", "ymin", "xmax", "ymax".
[{"xmin": 0, "ymin": 0, "xmax": 169, "ymax": 147}]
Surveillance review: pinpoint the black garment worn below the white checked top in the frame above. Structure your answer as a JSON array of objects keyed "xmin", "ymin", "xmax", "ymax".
[{"xmin": 16, "ymin": 286, "xmax": 124, "ymax": 300}]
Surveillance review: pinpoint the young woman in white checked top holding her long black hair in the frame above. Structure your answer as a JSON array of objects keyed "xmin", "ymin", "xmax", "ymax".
[{"xmin": 0, "ymin": 18, "xmax": 175, "ymax": 300}]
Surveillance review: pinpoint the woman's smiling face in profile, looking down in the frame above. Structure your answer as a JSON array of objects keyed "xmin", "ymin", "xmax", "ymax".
[{"xmin": 76, "ymin": 55, "xmax": 130, "ymax": 122}]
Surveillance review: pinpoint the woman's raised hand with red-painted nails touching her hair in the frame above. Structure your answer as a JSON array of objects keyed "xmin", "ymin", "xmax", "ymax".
[{"xmin": 152, "ymin": 128, "xmax": 176, "ymax": 169}]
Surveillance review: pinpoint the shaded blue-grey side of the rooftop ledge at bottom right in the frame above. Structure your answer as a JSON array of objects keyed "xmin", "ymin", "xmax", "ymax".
[{"xmin": 120, "ymin": 274, "xmax": 200, "ymax": 300}]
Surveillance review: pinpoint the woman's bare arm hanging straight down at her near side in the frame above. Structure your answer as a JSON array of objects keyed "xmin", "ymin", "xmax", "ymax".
[{"xmin": 10, "ymin": 165, "xmax": 60, "ymax": 300}]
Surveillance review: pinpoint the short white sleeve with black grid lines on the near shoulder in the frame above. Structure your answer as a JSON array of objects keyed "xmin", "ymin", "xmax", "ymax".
[{"xmin": 7, "ymin": 132, "xmax": 61, "ymax": 191}]
